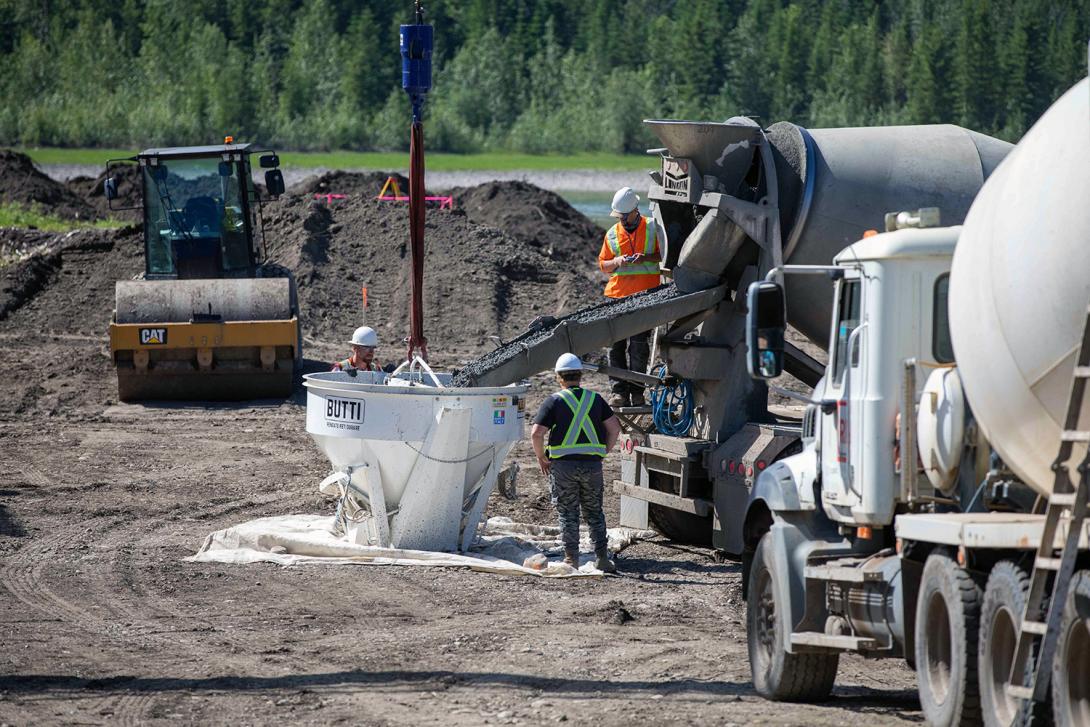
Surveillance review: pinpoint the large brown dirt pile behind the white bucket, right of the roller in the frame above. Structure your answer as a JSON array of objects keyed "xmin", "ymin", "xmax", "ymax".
[{"xmin": 265, "ymin": 172, "xmax": 600, "ymax": 356}]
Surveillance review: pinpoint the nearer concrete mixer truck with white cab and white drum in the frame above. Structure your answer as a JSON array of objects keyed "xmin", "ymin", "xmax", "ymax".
[{"xmin": 741, "ymin": 80, "xmax": 1090, "ymax": 725}]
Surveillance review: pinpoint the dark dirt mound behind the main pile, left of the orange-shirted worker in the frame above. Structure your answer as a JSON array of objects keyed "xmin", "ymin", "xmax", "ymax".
[{"xmin": 451, "ymin": 182, "xmax": 605, "ymax": 264}]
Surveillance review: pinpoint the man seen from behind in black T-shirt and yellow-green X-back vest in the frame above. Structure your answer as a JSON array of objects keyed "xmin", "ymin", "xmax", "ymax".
[{"xmin": 530, "ymin": 353, "xmax": 620, "ymax": 573}]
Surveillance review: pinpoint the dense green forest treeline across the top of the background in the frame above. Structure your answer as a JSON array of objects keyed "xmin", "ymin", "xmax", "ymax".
[{"xmin": 0, "ymin": 0, "xmax": 1090, "ymax": 153}]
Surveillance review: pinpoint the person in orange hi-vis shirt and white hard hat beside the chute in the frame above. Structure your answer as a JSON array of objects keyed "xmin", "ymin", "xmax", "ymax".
[{"xmin": 598, "ymin": 186, "xmax": 662, "ymax": 407}]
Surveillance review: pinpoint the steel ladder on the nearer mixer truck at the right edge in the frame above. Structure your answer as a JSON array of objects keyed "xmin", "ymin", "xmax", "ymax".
[{"xmin": 1007, "ymin": 308, "xmax": 1090, "ymax": 702}]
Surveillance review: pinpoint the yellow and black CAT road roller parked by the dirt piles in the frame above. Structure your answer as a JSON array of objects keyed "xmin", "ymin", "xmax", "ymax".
[{"xmin": 105, "ymin": 137, "xmax": 302, "ymax": 401}]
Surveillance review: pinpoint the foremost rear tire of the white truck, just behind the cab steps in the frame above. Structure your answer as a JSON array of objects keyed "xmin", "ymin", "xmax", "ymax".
[{"xmin": 916, "ymin": 553, "xmax": 981, "ymax": 727}]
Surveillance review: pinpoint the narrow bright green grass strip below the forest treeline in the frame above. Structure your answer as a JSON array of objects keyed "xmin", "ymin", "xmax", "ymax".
[{"xmin": 19, "ymin": 147, "xmax": 658, "ymax": 171}]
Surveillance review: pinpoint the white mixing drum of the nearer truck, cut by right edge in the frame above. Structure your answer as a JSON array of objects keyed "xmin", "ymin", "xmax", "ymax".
[{"xmin": 949, "ymin": 80, "xmax": 1090, "ymax": 495}]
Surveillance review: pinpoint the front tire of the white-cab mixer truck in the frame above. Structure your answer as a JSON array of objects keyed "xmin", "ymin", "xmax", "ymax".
[{"xmin": 746, "ymin": 534, "xmax": 840, "ymax": 702}]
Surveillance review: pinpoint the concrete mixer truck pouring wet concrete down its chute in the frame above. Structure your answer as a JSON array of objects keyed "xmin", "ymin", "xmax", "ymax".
[{"xmin": 457, "ymin": 107, "xmax": 1012, "ymax": 557}]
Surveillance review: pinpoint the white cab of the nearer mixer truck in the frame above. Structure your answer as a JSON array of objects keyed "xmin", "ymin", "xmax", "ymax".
[{"xmin": 789, "ymin": 227, "xmax": 960, "ymax": 529}]
